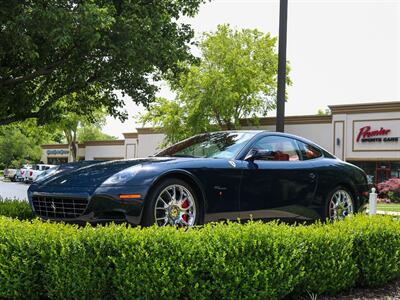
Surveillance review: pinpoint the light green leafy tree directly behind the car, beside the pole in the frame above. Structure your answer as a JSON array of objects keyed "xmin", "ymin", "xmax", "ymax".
[{"xmin": 141, "ymin": 25, "xmax": 290, "ymax": 143}]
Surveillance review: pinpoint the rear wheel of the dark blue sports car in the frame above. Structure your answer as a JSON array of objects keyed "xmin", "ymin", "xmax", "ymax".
[{"xmin": 324, "ymin": 186, "xmax": 355, "ymax": 221}]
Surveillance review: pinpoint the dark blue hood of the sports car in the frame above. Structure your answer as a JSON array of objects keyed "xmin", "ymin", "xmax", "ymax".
[{"xmin": 43, "ymin": 158, "xmax": 158, "ymax": 187}]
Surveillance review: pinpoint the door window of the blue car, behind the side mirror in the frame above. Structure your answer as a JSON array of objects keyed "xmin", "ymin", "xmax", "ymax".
[{"xmin": 253, "ymin": 135, "xmax": 300, "ymax": 161}]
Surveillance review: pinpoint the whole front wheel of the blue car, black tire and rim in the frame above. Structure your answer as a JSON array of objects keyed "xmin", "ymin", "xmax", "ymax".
[{"xmin": 141, "ymin": 178, "xmax": 201, "ymax": 227}]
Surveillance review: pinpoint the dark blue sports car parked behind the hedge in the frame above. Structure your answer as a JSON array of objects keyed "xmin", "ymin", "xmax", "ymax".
[{"xmin": 28, "ymin": 131, "xmax": 368, "ymax": 226}]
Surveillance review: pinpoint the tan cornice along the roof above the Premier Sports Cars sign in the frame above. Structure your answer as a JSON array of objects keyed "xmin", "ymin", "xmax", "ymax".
[{"xmin": 328, "ymin": 101, "xmax": 400, "ymax": 114}]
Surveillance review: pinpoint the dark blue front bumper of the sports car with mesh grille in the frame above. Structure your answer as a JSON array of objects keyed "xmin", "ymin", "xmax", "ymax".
[{"xmin": 28, "ymin": 185, "xmax": 148, "ymax": 224}]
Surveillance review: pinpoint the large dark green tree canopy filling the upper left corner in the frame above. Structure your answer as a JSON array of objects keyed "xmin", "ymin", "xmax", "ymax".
[{"xmin": 0, "ymin": 0, "xmax": 203, "ymax": 125}]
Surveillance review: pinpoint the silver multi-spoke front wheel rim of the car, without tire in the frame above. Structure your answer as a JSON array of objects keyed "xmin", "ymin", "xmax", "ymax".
[{"xmin": 154, "ymin": 184, "xmax": 196, "ymax": 226}]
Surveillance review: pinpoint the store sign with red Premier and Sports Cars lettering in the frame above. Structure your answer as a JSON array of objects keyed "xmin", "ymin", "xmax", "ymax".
[{"xmin": 353, "ymin": 119, "xmax": 400, "ymax": 151}]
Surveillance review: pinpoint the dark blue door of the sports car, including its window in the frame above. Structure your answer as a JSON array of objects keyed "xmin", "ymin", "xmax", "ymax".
[{"xmin": 240, "ymin": 135, "xmax": 317, "ymax": 218}]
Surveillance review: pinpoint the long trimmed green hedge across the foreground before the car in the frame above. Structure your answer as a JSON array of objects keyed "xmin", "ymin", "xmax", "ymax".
[{"xmin": 0, "ymin": 216, "xmax": 400, "ymax": 299}]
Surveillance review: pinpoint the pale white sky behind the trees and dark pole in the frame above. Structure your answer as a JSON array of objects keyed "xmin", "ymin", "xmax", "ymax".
[{"xmin": 103, "ymin": 0, "xmax": 400, "ymax": 138}]
